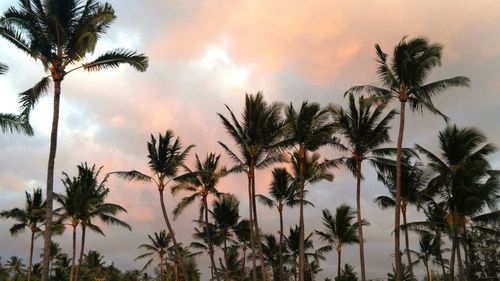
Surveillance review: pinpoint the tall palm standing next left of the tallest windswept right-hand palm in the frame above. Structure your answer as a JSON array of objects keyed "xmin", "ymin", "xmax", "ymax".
[{"xmin": 330, "ymin": 94, "xmax": 396, "ymax": 281}]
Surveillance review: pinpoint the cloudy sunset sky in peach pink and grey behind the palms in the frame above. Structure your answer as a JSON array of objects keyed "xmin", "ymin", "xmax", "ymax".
[{"xmin": 0, "ymin": 0, "xmax": 500, "ymax": 280}]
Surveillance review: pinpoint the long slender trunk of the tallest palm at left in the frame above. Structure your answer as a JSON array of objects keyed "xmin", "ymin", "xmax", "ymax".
[{"xmin": 42, "ymin": 80, "xmax": 61, "ymax": 281}]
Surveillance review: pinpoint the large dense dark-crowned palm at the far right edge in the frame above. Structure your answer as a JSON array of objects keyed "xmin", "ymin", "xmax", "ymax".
[{"xmin": 417, "ymin": 125, "xmax": 500, "ymax": 281}]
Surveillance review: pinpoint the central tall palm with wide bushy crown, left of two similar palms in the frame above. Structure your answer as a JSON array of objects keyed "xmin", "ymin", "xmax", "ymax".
[{"xmin": 218, "ymin": 92, "xmax": 283, "ymax": 281}]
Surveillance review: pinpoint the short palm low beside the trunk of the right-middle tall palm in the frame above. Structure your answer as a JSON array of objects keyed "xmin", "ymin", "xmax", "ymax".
[{"xmin": 316, "ymin": 204, "xmax": 366, "ymax": 276}]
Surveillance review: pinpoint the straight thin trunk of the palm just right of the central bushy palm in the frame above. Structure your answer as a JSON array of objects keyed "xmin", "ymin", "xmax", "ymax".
[{"xmin": 299, "ymin": 145, "xmax": 306, "ymax": 281}]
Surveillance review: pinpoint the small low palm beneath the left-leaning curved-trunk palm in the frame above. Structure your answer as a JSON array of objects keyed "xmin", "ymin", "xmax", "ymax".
[{"xmin": 134, "ymin": 230, "xmax": 172, "ymax": 280}]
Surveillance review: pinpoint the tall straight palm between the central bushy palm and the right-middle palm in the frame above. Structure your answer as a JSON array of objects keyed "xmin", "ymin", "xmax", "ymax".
[{"xmin": 282, "ymin": 101, "xmax": 334, "ymax": 281}]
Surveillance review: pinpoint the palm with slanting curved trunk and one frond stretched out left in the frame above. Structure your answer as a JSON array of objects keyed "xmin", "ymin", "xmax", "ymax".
[{"xmin": 114, "ymin": 130, "xmax": 194, "ymax": 280}]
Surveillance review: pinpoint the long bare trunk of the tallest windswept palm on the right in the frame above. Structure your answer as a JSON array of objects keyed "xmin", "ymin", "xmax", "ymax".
[{"xmin": 394, "ymin": 99, "xmax": 406, "ymax": 281}]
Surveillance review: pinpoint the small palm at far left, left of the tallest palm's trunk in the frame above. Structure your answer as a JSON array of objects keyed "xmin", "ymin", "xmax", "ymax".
[{"xmin": 0, "ymin": 188, "xmax": 46, "ymax": 281}]
